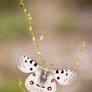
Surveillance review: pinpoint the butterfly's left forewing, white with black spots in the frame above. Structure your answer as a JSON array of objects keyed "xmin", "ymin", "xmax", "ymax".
[{"xmin": 18, "ymin": 56, "xmax": 39, "ymax": 73}]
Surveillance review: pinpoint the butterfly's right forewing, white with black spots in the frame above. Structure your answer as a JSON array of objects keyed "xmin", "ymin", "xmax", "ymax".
[{"xmin": 53, "ymin": 69, "xmax": 76, "ymax": 85}]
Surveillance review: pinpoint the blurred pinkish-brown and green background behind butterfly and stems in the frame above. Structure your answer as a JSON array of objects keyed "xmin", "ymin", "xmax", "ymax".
[{"xmin": 0, "ymin": 0, "xmax": 92, "ymax": 92}]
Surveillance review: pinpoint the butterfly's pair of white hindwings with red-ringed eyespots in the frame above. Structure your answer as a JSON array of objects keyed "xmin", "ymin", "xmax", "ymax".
[{"xmin": 25, "ymin": 70, "xmax": 56, "ymax": 92}]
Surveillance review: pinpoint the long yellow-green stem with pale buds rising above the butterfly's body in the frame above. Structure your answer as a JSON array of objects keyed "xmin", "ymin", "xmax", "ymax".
[{"xmin": 19, "ymin": 0, "xmax": 46, "ymax": 68}]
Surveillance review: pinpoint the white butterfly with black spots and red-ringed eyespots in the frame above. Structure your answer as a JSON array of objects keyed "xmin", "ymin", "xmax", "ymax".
[{"xmin": 18, "ymin": 56, "xmax": 76, "ymax": 92}]
